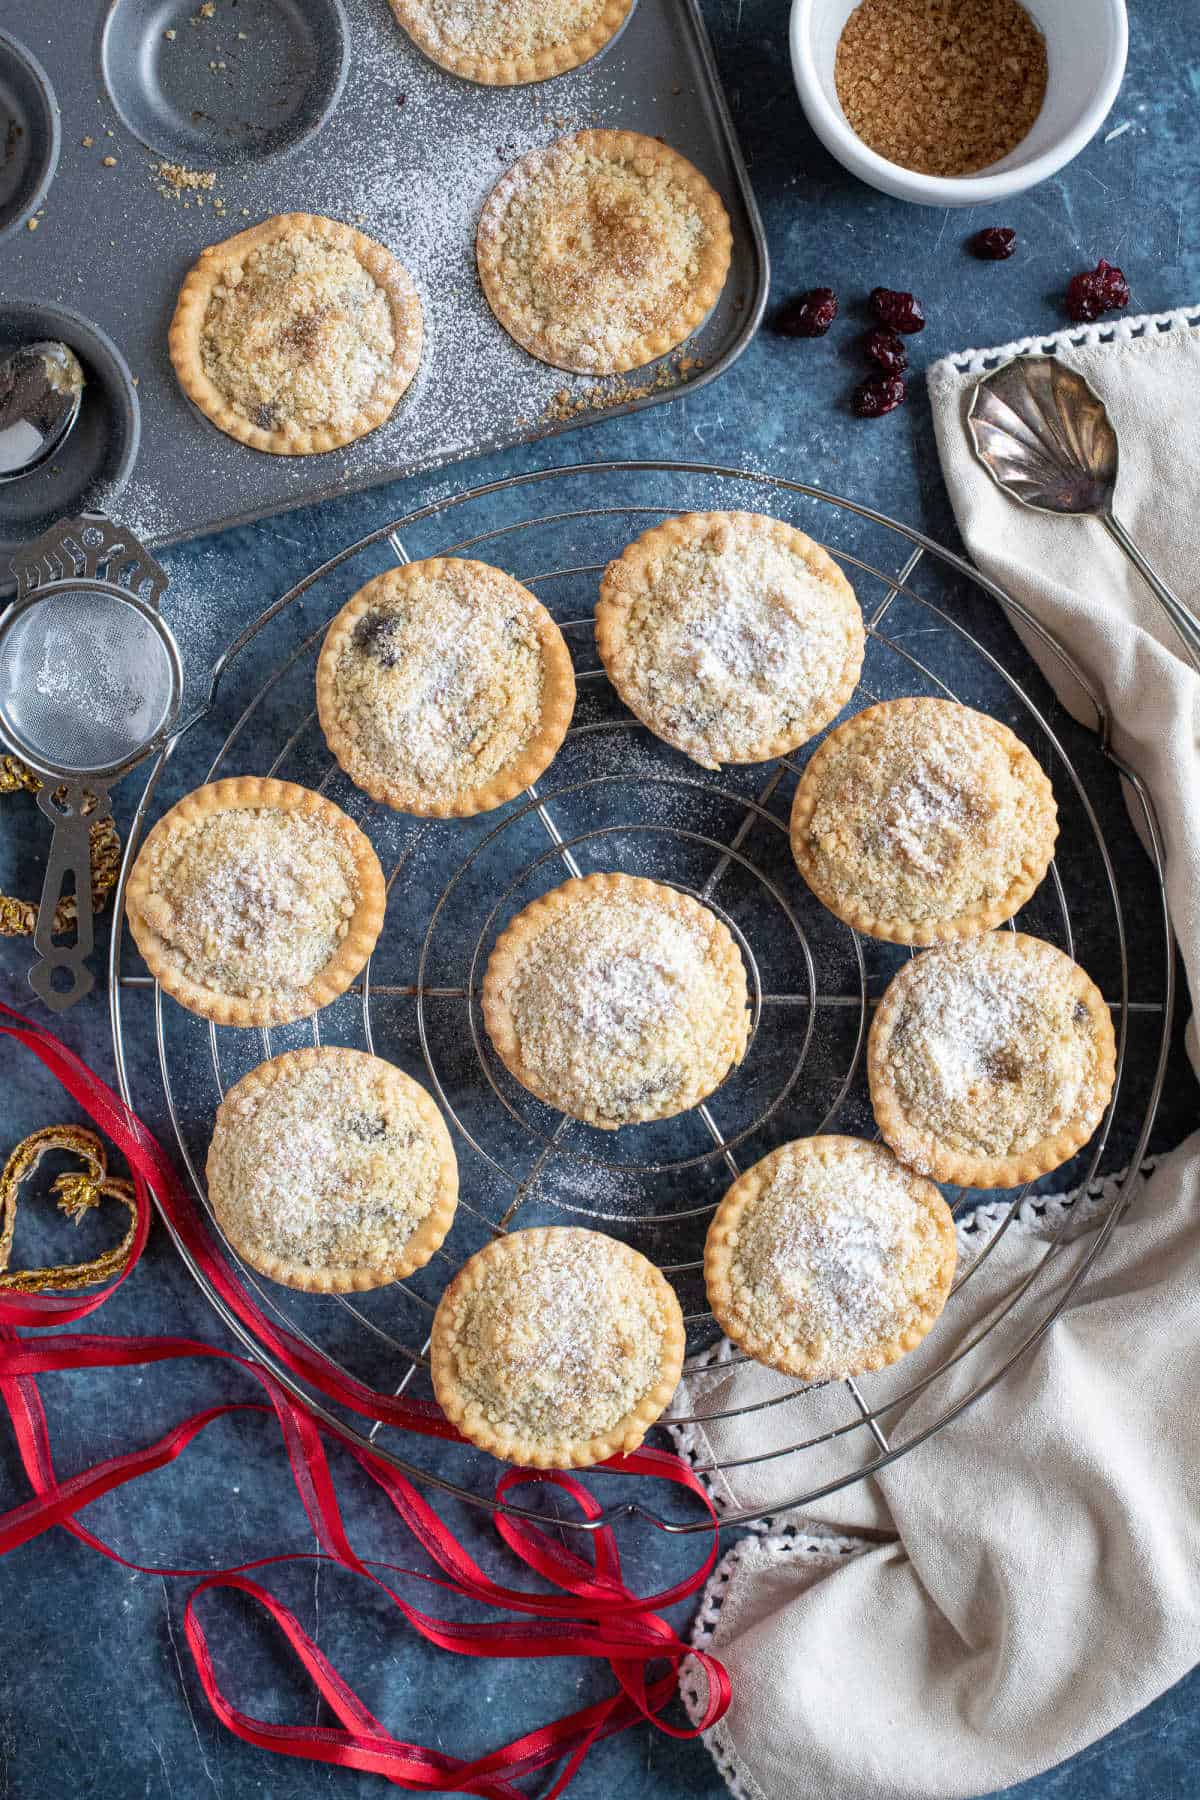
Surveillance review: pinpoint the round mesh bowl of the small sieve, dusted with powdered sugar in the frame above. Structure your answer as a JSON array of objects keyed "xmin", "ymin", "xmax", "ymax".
[{"xmin": 0, "ymin": 587, "xmax": 178, "ymax": 776}]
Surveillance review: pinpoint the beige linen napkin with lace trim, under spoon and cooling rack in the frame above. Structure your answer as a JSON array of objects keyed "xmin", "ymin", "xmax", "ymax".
[{"xmin": 676, "ymin": 311, "xmax": 1200, "ymax": 1800}]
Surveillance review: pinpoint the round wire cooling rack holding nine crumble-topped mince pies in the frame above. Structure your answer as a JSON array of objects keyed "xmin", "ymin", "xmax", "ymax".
[{"xmin": 110, "ymin": 463, "xmax": 1175, "ymax": 1534}]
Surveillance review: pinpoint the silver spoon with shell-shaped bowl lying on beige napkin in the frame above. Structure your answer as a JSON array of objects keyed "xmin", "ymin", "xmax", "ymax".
[{"xmin": 966, "ymin": 356, "xmax": 1200, "ymax": 673}]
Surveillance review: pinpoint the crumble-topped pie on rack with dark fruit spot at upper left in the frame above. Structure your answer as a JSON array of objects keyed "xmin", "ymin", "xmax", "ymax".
[{"xmin": 317, "ymin": 556, "xmax": 576, "ymax": 817}]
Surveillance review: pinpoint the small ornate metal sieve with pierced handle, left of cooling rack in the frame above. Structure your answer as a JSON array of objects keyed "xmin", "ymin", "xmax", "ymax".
[{"xmin": 0, "ymin": 515, "xmax": 184, "ymax": 1012}]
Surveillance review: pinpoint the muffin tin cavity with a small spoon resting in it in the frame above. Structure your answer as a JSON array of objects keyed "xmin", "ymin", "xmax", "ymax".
[{"xmin": 0, "ymin": 299, "xmax": 140, "ymax": 558}]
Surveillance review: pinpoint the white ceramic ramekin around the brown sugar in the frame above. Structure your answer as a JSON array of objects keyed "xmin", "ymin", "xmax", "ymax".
[{"xmin": 790, "ymin": 0, "xmax": 1130, "ymax": 207}]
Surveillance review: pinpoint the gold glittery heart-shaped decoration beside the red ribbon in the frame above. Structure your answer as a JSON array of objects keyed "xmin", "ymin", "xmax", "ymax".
[{"xmin": 0, "ymin": 1125, "xmax": 137, "ymax": 1294}]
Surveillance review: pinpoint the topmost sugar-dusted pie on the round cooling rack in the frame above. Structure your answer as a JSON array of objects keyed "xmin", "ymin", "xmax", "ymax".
[{"xmin": 596, "ymin": 513, "xmax": 865, "ymax": 769}]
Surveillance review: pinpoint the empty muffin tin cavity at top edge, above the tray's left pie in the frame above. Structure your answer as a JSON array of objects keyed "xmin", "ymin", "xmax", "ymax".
[{"xmin": 101, "ymin": 0, "xmax": 349, "ymax": 169}]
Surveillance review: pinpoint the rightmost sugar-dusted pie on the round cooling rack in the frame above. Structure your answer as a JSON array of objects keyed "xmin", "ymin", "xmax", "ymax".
[{"xmin": 867, "ymin": 931, "xmax": 1115, "ymax": 1188}]
